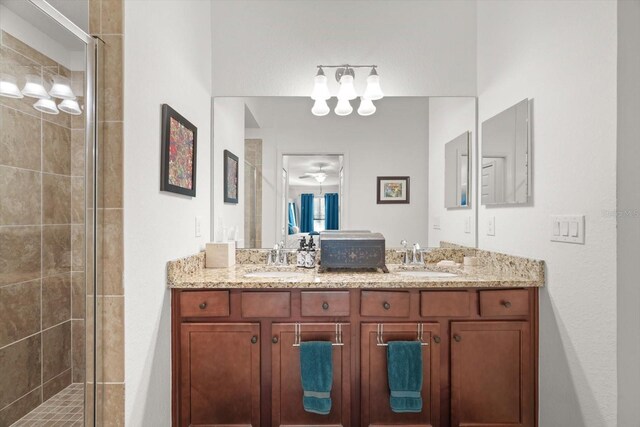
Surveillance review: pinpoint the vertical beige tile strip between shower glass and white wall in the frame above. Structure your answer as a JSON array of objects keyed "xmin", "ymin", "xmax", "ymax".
[{"xmin": 89, "ymin": 0, "xmax": 124, "ymax": 426}]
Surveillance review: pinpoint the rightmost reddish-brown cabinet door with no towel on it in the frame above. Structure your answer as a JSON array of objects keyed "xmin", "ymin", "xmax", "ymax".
[{"xmin": 451, "ymin": 321, "xmax": 534, "ymax": 427}]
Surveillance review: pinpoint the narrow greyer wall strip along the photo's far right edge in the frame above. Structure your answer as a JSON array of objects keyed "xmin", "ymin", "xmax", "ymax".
[{"xmin": 617, "ymin": 0, "xmax": 640, "ymax": 426}]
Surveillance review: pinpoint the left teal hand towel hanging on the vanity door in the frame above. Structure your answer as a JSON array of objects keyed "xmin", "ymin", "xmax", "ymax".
[{"xmin": 300, "ymin": 341, "xmax": 333, "ymax": 415}]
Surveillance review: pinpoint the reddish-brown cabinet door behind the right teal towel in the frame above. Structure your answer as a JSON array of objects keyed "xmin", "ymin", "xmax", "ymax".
[{"xmin": 360, "ymin": 323, "xmax": 440, "ymax": 427}]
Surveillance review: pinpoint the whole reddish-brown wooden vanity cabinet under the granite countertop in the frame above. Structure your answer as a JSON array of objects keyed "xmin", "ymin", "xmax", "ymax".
[{"xmin": 172, "ymin": 288, "xmax": 538, "ymax": 427}]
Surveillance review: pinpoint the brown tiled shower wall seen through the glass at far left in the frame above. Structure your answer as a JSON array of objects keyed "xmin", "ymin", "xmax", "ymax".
[{"xmin": 0, "ymin": 32, "xmax": 79, "ymax": 426}]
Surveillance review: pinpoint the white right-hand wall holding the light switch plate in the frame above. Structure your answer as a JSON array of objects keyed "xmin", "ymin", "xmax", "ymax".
[{"xmin": 478, "ymin": 0, "xmax": 616, "ymax": 427}]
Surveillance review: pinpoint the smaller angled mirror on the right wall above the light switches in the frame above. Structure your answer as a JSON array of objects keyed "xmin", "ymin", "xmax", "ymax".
[{"xmin": 481, "ymin": 99, "xmax": 531, "ymax": 205}]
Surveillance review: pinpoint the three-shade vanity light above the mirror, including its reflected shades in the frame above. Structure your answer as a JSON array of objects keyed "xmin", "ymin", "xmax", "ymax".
[{"xmin": 311, "ymin": 64, "xmax": 384, "ymax": 116}]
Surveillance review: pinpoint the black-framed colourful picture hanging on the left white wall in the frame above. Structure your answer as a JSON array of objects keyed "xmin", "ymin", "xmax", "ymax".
[{"xmin": 160, "ymin": 104, "xmax": 198, "ymax": 197}]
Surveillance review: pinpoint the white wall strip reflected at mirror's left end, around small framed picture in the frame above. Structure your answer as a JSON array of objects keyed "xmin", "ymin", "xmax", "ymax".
[{"xmin": 211, "ymin": 98, "xmax": 245, "ymax": 248}]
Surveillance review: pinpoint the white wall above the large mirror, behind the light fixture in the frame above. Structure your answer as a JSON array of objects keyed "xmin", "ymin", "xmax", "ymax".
[{"xmin": 213, "ymin": 0, "xmax": 476, "ymax": 96}]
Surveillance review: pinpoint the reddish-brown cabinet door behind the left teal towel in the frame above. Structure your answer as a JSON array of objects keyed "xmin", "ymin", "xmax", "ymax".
[{"xmin": 271, "ymin": 323, "xmax": 351, "ymax": 427}]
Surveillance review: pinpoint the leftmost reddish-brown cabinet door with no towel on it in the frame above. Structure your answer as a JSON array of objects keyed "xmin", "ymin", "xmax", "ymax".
[{"xmin": 180, "ymin": 323, "xmax": 260, "ymax": 427}]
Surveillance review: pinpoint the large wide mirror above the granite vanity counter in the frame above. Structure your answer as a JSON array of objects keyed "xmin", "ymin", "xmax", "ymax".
[{"xmin": 212, "ymin": 97, "xmax": 476, "ymax": 249}]
